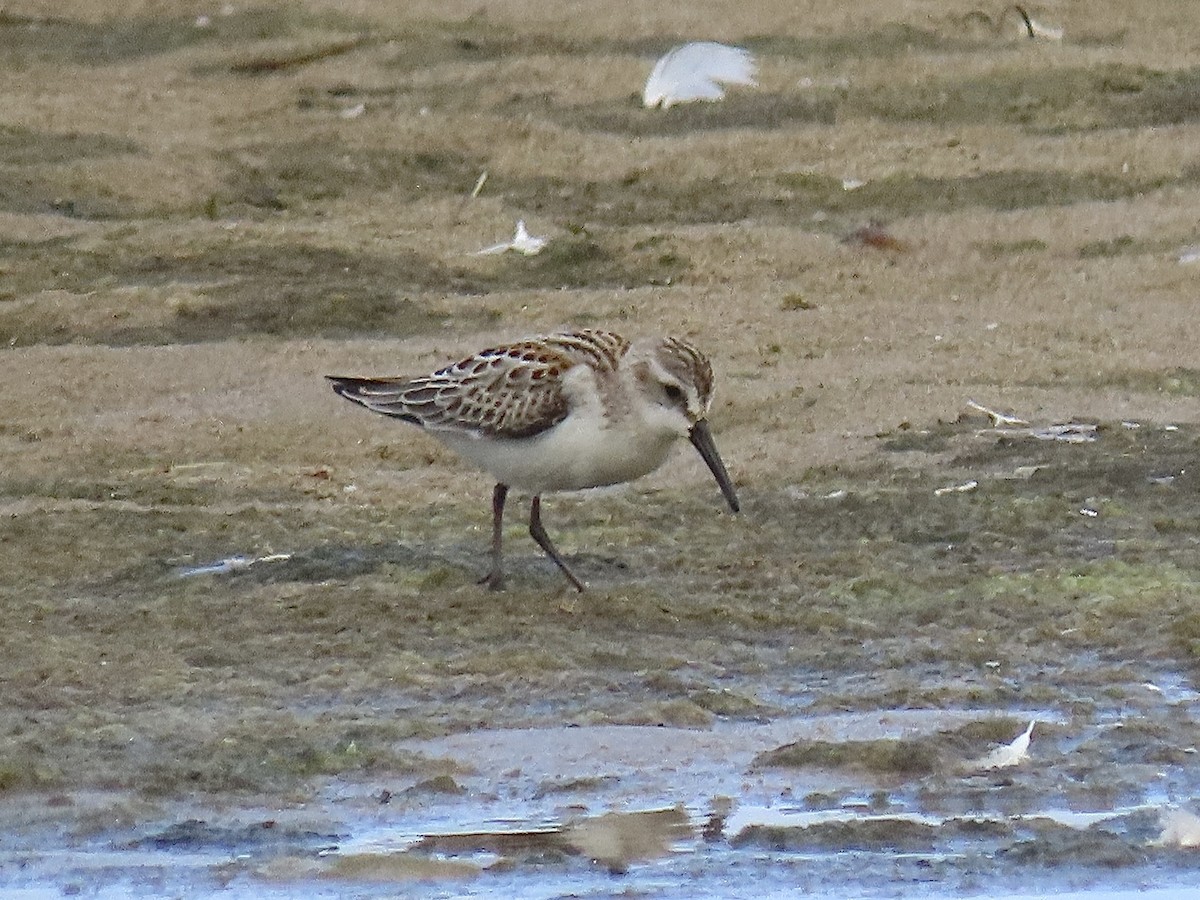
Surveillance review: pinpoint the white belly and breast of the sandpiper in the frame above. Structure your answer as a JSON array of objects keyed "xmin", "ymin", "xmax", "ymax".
[{"xmin": 432, "ymin": 415, "xmax": 679, "ymax": 493}]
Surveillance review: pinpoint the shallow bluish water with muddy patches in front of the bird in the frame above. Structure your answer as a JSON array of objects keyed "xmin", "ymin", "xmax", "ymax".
[{"xmin": 7, "ymin": 710, "xmax": 1200, "ymax": 900}]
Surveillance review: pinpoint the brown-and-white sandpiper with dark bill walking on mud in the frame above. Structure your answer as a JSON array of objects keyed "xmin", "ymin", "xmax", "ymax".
[{"xmin": 326, "ymin": 330, "xmax": 738, "ymax": 590}]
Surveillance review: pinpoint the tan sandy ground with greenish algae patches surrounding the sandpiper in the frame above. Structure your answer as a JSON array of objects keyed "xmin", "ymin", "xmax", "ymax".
[{"xmin": 0, "ymin": 0, "xmax": 1200, "ymax": 895}]
